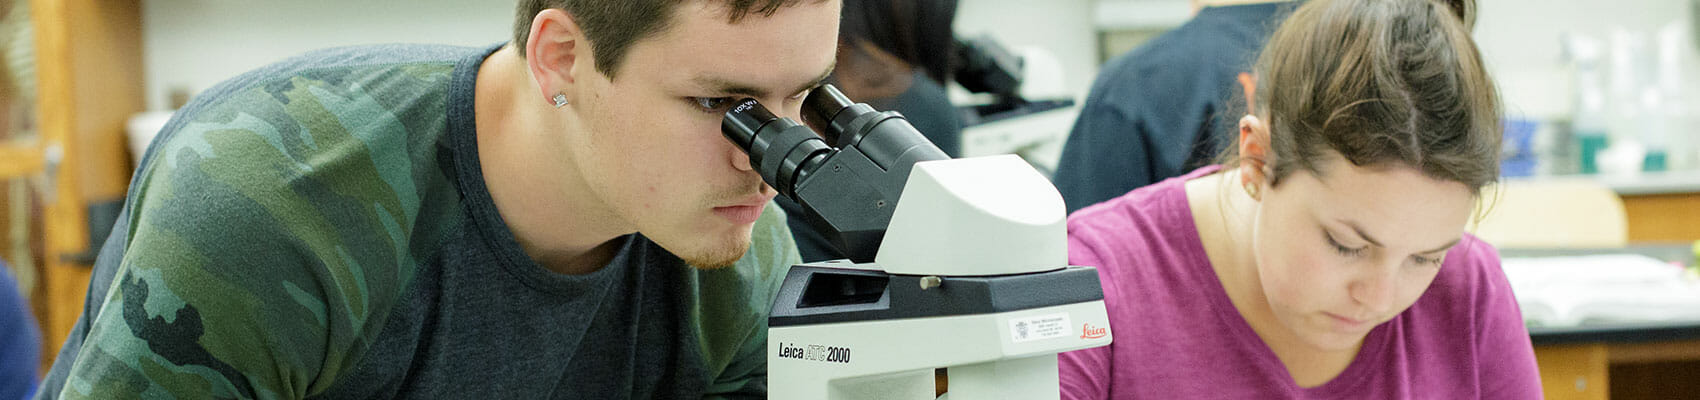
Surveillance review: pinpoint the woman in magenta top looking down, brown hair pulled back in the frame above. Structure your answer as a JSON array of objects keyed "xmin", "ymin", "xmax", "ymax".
[{"xmin": 1059, "ymin": 0, "xmax": 1542, "ymax": 400}]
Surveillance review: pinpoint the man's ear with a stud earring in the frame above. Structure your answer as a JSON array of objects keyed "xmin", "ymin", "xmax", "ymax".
[{"xmin": 525, "ymin": 9, "xmax": 595, "ymax": 106}]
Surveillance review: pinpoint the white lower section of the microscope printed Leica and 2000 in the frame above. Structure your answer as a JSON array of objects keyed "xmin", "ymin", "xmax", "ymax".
[{"xmin": 767, "ymin": 300, "xmax": 1110, "ymax": 400}]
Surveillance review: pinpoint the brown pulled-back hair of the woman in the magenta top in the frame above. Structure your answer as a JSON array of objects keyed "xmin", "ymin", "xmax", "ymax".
[{"xmin": 1222, "ymin": 0, "xmax": 1503, "ymax": 191}]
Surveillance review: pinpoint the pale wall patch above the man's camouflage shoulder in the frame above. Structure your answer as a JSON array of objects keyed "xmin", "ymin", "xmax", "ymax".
[{"xmin": 141, "ymin": 0, "xmax": 513, "ymax": 111}]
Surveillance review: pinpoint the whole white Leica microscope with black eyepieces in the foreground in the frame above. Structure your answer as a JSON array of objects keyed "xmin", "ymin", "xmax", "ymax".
[{"xmin": 721, "ymin": 85, "xmax": 1110, "ymax": 400}]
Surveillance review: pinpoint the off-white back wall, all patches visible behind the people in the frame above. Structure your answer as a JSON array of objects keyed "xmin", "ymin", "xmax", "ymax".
[{"xmin": 143, "ymin": 0, "xmax": 1700, "ymax": 117}]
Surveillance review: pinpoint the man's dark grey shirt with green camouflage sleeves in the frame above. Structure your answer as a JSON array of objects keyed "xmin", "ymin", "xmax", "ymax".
[{"xmin": 37, "ymin": 46, "xmax": 797, "ymax": 398}]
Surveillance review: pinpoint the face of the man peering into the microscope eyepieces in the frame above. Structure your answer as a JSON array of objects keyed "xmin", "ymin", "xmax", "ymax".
[{"xmin": 564, "ymin": 0, "xmax": 840, "ymax": 267}]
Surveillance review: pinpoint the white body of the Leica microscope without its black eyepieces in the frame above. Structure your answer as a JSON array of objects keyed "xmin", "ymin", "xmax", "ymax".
[{"xmin": 767, "ymin": 155, "xmax": 1110, "ymax": 400}]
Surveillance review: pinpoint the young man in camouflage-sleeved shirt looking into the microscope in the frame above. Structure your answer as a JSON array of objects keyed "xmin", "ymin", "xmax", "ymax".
[{"xmin": 41, "ymin": 0, "xmax": 842, "ymax": 398}]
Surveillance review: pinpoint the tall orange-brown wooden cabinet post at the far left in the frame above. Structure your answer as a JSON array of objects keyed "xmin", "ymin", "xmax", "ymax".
[{"xmin": 21, "ymin": 0, "xmax": 143, "ymax": 364}]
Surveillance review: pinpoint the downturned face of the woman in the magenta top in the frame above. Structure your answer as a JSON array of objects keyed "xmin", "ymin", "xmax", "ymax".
[{"xmin": 1251, "ymin": 155, "xmax": 1476, "ymax": 351}]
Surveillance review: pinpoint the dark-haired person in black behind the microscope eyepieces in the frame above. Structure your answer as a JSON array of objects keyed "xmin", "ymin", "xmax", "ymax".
[{"xmin": 775, "ymin": 0, "xmax": 962, "ymax": 262}]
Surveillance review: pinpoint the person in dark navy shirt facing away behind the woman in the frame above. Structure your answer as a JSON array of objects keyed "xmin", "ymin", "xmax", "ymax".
[{"xmin": 1052, "ymin": 0, "xmax": 1294, "ymax": 213}]
